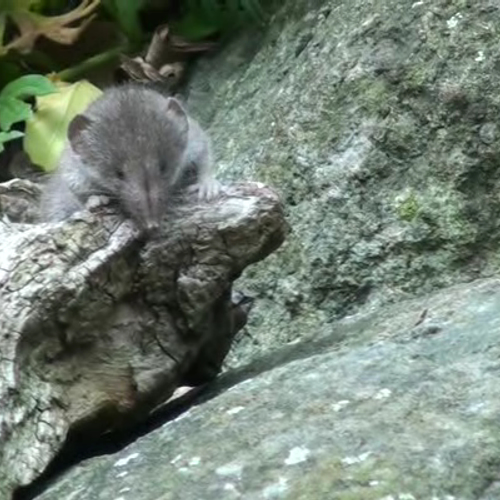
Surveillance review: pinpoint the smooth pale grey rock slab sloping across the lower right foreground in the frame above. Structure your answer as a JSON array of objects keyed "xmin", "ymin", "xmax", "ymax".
[{"xmin": 31, "ymin": 279, "xmax": 500, "ymax": 500}]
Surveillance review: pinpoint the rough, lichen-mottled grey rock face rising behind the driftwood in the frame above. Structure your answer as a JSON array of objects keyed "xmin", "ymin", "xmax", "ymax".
[{"xmin": 184, "ymin": 0, "xmax": 500, "ymax": 364}]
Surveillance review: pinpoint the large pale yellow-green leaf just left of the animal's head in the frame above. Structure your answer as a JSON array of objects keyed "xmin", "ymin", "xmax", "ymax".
[{"xmin": 23, "ymin": 80, "xmax": 102, "ymax": 171}]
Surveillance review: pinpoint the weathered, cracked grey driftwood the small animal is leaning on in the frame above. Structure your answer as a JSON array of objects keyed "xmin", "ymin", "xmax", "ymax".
[{"xmin": 0, "ymin": 181, "xmax": 287, "ymax": 498}]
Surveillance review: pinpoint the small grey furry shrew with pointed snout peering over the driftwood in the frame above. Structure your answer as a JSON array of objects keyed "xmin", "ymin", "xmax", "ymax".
[{"xmin": 41, "ymin": 85, "xmax": 220, "ymax": 230}]
